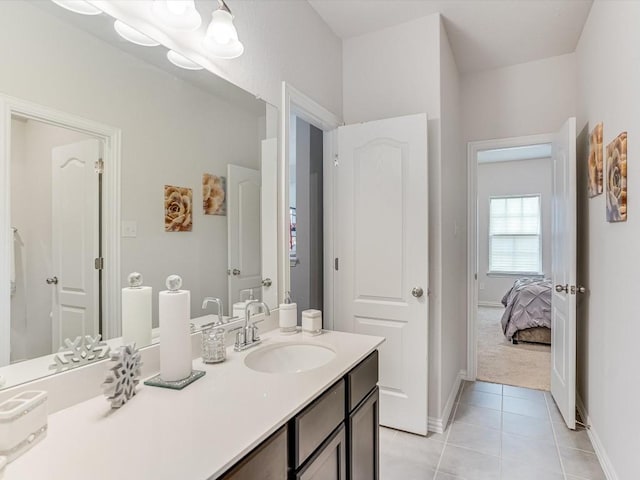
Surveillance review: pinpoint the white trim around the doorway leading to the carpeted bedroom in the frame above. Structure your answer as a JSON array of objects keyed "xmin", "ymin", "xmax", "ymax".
[{"xmin": 466, "ymin": 134, "xmax": 553, "ymax": 380}]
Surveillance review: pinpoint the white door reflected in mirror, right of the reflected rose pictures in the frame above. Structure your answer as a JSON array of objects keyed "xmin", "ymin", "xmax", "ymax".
[{"xmin": 227, "ymin": 165, "xmax": 262, "ymax": 308}]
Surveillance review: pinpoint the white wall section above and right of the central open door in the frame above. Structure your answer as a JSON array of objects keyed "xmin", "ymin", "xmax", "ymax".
[{"xmin": 343, "ymin": 14, "xmax": 466, "ymax": 419}]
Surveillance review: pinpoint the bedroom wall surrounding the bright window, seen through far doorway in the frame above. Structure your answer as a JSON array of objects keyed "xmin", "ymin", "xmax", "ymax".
[{"xmin": 478, "ymin": 158, "xmax": 553, "ymax": 304}]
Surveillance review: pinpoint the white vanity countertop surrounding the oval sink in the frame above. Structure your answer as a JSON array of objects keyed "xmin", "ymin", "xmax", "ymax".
[{"xmin": 4, "ymin": 330, "xmax": 384, "ymax": 480}]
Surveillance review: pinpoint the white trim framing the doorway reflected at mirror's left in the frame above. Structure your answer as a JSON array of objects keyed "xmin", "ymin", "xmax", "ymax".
[{"xmin": 0, "ymin": 95, "xmax": 121, "ymax": 365}]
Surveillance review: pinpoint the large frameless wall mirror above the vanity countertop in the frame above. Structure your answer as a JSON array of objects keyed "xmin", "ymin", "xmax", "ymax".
[{"xmin": 0, "ymin": 0, "xmax": 278, "ymax": 388}]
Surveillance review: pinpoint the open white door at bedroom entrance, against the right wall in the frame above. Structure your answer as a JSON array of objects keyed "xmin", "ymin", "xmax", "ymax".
[{"xmin": 551, "ymin": 117, "xmax": 577, "ymax": 429}]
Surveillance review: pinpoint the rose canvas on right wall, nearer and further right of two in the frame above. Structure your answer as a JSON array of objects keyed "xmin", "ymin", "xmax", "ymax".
[{"xmin": 607, "ymin": 132, "xmax": 627, "ymax": 222}]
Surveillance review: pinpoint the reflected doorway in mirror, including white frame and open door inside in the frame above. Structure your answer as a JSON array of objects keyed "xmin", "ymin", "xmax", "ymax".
[{"xmin": 0, "ymin": 96, "xmax": 120, "ymax": 365}]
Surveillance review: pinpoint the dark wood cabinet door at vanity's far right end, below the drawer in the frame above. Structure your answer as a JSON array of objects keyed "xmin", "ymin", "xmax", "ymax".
[{"xmin": 347, "ymin": 387, "xmax": 380, "ymax": 480}]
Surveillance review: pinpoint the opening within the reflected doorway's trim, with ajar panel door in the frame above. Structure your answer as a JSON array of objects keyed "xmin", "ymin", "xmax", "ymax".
[{"xmin": 10, "ymin": 115, "xmax": 102, "ymax": 363}]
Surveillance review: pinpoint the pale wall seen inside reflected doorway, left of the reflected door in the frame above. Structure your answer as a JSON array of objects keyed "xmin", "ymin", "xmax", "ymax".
[{"xmin": 11, "ymin": 119, "xmax": 97, "ymax": 362}]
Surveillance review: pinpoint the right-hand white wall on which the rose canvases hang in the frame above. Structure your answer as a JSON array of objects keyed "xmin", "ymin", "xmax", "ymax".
[{"xmin": 576, "ymin": 1, "xmax": 640, "ymax": 480}]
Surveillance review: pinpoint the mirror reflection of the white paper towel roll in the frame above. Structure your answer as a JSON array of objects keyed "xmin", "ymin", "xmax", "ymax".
[{"xmin": 122, "ymin": 287, "xmax": 153, "ymax": 347}]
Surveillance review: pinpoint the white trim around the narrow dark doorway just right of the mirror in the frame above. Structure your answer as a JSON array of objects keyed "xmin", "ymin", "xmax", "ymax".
[{"xmin": 278, "ymin": 82, "xmax": 342, "ymax": 322}]
